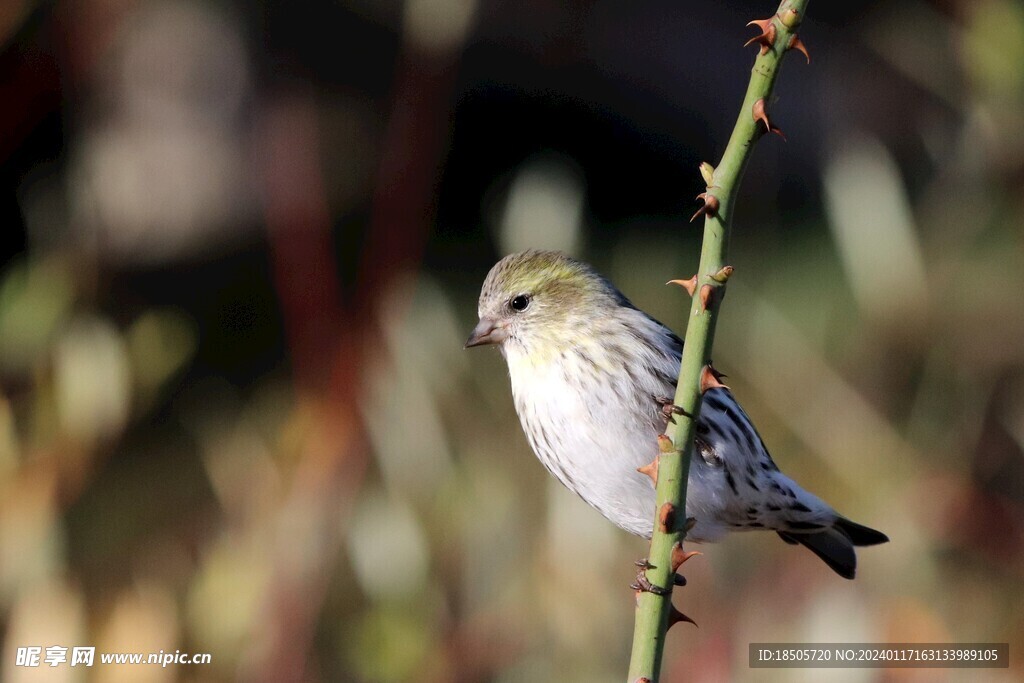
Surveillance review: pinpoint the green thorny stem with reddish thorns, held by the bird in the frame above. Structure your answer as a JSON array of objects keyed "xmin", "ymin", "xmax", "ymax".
[{"xmin": 627, "ymin": 0, "xmax": 809, "ymax": 683}]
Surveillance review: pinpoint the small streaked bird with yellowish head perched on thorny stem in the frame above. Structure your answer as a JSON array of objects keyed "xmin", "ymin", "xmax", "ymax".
[{"xmin": 466, "ymin": 250, "xmax": 889, "ymax": 579}]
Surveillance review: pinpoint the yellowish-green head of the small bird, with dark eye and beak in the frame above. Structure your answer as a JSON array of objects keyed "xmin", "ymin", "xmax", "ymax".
[{"xmin": 466, "ymin": 250, "xmax": 629, "ymax": 353}]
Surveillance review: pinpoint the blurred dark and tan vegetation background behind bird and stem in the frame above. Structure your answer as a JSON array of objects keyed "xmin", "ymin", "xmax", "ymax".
[{"xmin": 0, "ymin": 0, "xmax": 1024, "ymax": 683}]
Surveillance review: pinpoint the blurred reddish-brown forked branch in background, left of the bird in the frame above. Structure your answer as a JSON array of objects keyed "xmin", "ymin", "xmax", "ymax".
[{"xmin": 250, "ymin": 15, "xmax": 461, "ymax": 681}]
